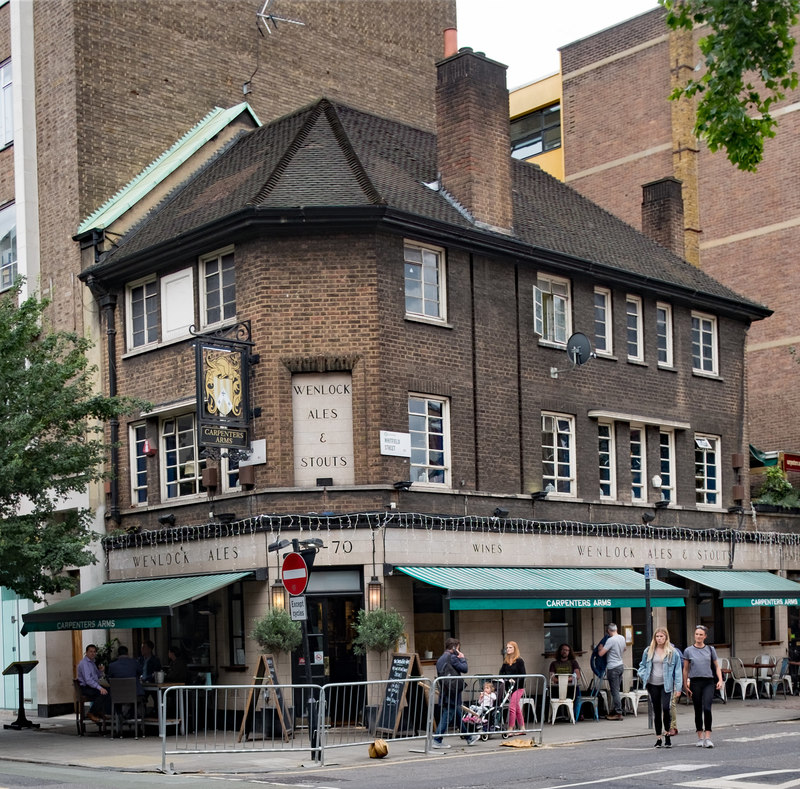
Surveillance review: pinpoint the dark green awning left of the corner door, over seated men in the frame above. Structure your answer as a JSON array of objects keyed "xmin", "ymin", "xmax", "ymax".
[{"xmin": 22, "ymin": 571, "xmax": 250, "ymax": 635}]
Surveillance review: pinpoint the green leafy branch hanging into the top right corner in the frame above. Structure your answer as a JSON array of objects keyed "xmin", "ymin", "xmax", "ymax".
[{"xmin": 659, "ymin": 0, "xmax": 800, "ymax": 172}]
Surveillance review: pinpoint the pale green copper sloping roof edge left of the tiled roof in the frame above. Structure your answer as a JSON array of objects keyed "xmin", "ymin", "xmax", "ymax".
[{"xmin": 78, "ymin": 101, "xmax": 261, "ymax": 235}]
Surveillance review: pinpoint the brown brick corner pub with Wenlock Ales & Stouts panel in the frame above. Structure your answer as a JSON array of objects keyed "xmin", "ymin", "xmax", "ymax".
[{"xmin": 9, "ymin": 3, "xmax": 800, "ymax": 716}]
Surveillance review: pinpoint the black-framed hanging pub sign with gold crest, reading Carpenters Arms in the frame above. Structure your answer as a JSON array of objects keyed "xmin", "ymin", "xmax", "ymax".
[{"xmin": 195, "ymin": 323, "xmax": 253, "ymax": 449}]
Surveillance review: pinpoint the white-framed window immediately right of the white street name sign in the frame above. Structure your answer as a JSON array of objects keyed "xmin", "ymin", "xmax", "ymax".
[{"xmin": 408, "ymin": 395, "xmax": 450, "ymax": 485}]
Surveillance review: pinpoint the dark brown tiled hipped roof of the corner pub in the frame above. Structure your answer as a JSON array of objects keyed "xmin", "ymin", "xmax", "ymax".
[{"xmin": 93, "ymin": 99, "xmax": 768, "ymax": 315}]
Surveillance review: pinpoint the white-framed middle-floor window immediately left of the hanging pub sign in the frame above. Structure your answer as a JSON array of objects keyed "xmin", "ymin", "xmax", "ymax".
[{"xmin": 161, "ymin": 413, "xmax": 205, "ymax": 500}]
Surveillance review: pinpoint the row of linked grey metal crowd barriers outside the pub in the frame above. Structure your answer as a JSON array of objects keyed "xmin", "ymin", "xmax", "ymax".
[{"xmin": 158, "ymin": 674, "xmax": 547, "ymax": 772}]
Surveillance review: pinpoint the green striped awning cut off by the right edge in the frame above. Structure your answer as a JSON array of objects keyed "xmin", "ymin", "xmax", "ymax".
[{"xmin": 672, "ymin": 570, "xmax": 800, "ymax": 608}]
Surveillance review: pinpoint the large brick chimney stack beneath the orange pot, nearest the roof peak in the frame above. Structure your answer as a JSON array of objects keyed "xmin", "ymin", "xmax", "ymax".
[{"xmin": 436, "ymin": 47, "xmax": 513, "ymax": 233}]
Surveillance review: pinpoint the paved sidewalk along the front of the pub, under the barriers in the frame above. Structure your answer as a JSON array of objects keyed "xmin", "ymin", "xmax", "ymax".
[{"xmin": 0, "ymin": 696, "xmax": 800, "ymax": 775}]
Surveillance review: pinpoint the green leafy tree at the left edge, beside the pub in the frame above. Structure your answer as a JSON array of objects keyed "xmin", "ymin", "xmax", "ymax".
[{"xmin": 0, "ymin": 286, "xmax": 143, "ymax": 600}]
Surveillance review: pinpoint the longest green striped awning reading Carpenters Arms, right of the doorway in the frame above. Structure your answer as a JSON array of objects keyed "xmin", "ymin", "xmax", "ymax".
[{"xmin": 395, "ymin": 567, "xmax": 686, "ymax": 611}]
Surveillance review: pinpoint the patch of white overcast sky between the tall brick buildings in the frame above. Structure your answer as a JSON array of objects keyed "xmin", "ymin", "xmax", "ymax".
[{"xmin": 456, "ymin": 0, "xmax": 658, "ymax": 88}]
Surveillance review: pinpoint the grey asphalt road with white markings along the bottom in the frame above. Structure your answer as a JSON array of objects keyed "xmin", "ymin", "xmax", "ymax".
[{"xmin": 0, "ymin": 723, "xmax": 800, "ymax": 789}]
